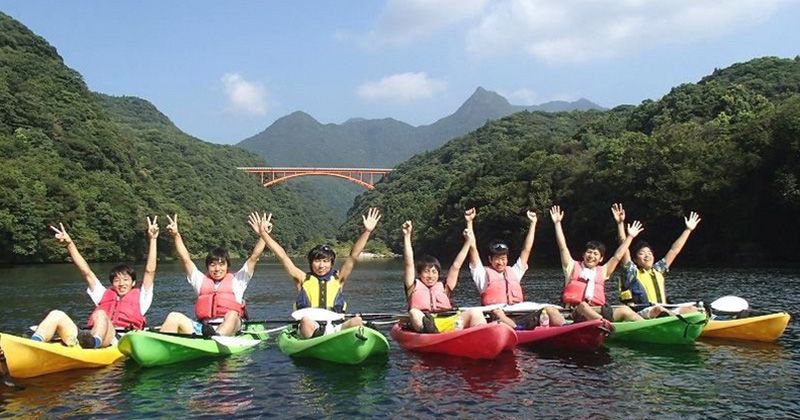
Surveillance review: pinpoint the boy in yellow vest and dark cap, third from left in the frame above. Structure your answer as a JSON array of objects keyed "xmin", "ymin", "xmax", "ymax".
[{"xmin": 260, "ymin": 208, "xmax": 381, "ymax": 338}]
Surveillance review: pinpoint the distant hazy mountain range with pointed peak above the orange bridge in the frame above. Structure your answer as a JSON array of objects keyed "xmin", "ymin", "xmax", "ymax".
[{"xmin": 238, "ymin": 87, "xmax": 601, "ymax": 167}]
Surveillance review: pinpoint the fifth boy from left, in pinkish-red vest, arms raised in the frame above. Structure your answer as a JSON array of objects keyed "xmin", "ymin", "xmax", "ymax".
[{"xmin": 464, "ymin": 208, "xmax": 564, "ymax": 330}]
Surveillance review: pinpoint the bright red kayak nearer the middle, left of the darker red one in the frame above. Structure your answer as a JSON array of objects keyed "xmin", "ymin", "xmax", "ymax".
[{"xmin": 391, "ymin": 322, "xmax": 517, "ymax": 359}]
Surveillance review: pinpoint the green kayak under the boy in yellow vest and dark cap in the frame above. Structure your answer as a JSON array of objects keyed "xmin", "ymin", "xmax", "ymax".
[{"xmin": 278, "ymin": 327, "xmax": 389, "ymax": 365}]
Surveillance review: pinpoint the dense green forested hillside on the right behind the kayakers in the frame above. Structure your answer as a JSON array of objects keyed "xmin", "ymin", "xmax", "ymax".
[{"xmin": 344, "ymin": 58, "xmax": 800, "ymax": 265}]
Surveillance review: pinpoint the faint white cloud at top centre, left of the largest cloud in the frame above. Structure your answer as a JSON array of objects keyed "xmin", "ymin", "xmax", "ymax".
[{"xmin": 364, "ymin": 0, "xmax": 488, "ymax": 46}]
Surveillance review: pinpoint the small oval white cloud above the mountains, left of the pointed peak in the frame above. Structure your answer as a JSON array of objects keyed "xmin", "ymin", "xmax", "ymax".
[{"xmin": 358, "ymin": 72, "xmax": 447, "ymax": 102}]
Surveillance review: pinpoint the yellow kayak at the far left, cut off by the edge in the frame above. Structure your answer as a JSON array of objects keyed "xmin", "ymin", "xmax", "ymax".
[{"xmin": 0, "ymin": 333, "xmax": 125, "ymax": 378}]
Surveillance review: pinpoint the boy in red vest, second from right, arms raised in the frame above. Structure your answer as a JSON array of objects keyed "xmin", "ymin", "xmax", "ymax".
[{"xmin": 550, "ymin": 206, "xmax": 644, "ymax": 322}]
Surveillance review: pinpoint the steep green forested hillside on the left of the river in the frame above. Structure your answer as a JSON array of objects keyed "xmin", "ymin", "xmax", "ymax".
[{"xmin": 0, "ymin": 13, "xmax": 336, "ymax": 263}]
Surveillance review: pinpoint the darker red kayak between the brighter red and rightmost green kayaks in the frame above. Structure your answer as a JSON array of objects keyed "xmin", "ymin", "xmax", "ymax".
[{"xmin": 516, "ymin": 319, "xmax": 614, "ymax": 351}]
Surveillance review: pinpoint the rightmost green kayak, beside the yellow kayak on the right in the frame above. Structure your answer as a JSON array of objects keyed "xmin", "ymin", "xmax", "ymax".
[{"xmin": 606, "ymin": 312, "xmax": 707, "ymax": 344}]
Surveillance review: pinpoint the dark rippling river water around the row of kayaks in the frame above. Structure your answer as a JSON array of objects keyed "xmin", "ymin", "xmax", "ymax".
[{"xmin": 0, "ymin": 260, "xmax": 800, "ymax": 419}]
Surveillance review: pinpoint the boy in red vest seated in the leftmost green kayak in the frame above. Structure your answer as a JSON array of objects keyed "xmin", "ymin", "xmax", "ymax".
[{"xmin": 161, "ymin": 213, "xmax": 265, "ymax": 336}]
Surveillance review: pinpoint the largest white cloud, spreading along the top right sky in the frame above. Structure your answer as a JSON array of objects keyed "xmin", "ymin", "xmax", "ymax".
[{"xmin": 466, "ymin": 0, "xmax": 785, "ymax": 63}]
